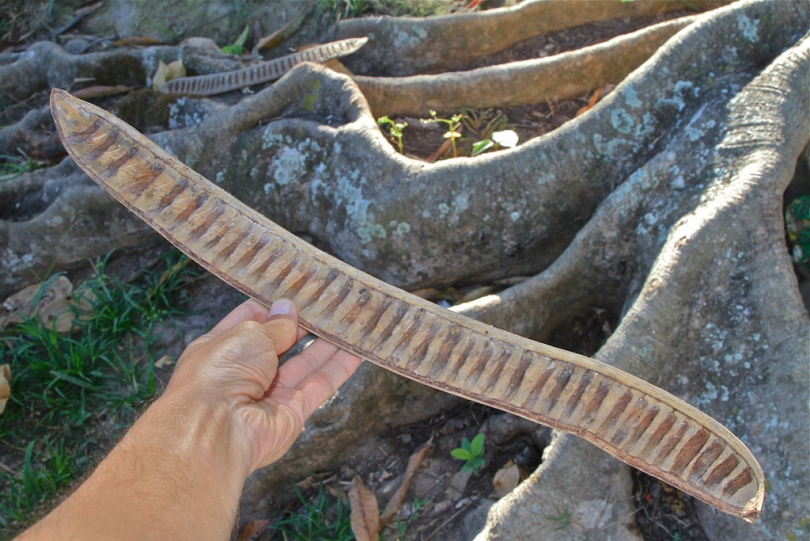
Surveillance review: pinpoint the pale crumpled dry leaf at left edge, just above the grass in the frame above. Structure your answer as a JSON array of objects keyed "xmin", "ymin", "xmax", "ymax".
[{"xmin": 0, "ymin": 275, "xmax": 93, "ymax": 333}]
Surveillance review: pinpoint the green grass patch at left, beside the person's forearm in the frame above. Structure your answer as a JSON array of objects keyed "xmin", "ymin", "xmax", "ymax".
[{"xmin": 0, "ymin": 252, "xmax": 197, "ymax": 538}]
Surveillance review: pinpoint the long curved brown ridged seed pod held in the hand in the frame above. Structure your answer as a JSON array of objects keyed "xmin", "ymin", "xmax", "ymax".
[{"xmin": 51, "ymin": 90, "xmax": 765, "ymax": 522}]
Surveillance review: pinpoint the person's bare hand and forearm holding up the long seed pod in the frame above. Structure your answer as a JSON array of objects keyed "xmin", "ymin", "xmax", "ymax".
[{"xmin": 17, "ymin": 301, "xmax": 360, "ymax": 540}]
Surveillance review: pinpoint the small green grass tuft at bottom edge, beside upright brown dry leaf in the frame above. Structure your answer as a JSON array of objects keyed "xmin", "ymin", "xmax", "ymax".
[{"xmin": 273, "ymin": 485, "xmax": 354, "ymax": 541}]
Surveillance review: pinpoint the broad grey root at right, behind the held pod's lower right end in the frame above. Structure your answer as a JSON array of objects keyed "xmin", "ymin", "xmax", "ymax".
[{"xmin": 459, "ymin": 3, "xmax": 810, "ymax": 540}]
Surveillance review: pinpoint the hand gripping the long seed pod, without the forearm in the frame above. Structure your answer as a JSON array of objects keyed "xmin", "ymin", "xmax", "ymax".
[{"xmin": 161, "ymin": 300, "xmax": 361, "ymax": 474}]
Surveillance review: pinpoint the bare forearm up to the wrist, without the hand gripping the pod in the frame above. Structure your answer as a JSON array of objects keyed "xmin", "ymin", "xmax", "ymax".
[{"xmin": 19, "ymin": 393, "xmax": 248, "ymax": 540}]
